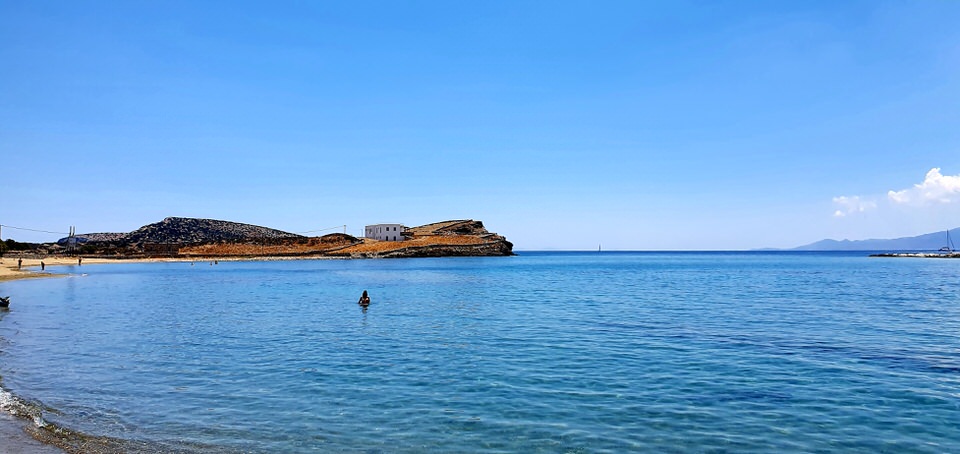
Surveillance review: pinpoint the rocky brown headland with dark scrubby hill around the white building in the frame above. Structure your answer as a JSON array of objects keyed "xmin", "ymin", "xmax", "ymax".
[{"xmin": 5, "ymin": 217, "xmax": 513, "ymax": 259}]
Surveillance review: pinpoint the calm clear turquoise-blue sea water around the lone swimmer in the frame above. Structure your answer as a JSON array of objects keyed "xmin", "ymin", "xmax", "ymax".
[{"xmin": 0, "ymin": 252, "xmax": 960, "ymax": 453}]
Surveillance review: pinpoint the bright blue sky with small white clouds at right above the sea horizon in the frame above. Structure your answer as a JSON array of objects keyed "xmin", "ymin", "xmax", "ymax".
[{"xmin": 0, "ymin": 0, "xmax": 960, "ymax": 249}]
